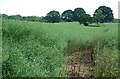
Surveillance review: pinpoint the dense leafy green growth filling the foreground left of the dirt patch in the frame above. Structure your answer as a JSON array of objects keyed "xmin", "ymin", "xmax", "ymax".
[{"xmin": 2, "ymin": 20, "xmax": 65, "ymax": 77}]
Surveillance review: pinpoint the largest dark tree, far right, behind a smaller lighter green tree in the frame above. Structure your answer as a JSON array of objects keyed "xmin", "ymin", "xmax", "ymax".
[{"xmin": 95, "ymin": 6, "xmax": 114, "ymax": 22}]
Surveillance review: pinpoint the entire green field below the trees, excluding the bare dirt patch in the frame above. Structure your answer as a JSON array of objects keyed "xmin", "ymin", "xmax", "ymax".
[{"xmin": 2, "ymin": 20, "xmax": 118, "ymax": 77}]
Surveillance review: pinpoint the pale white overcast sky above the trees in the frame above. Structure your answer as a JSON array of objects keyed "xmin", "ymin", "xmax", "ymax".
[{"xmin": 0, "ymin": 0, "xmax": 120, "ymax": 18}]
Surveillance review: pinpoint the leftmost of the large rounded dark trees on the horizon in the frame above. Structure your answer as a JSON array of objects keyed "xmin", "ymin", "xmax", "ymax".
[{"xmin": 45, "ymin": 10, "xmax": 60, "ymax": 23}]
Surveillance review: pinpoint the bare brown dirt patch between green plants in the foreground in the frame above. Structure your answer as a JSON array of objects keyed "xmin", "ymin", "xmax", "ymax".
[{"xmin": 65, "ymin": 48, "xmax": 94, "ymax": 77}]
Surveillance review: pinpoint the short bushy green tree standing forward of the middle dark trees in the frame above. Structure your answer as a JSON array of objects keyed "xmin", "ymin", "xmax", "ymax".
[{"xmin": 79, "ymin": 13, "xmax": 93, "ymax": 26}]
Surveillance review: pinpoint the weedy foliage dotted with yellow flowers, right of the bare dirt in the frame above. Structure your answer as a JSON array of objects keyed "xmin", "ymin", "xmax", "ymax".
[{"xmin": 94, "ymin": 39, "xmax": 119, "ymax": 77}]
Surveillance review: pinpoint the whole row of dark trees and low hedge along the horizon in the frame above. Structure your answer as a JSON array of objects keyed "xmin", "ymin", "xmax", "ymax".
[{"xmin": 2, "ymin": 6, "xmax": 114, "ymax": 26}]
